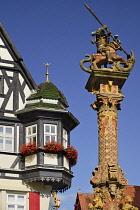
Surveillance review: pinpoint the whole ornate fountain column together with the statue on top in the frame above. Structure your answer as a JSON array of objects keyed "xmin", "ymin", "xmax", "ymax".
[{"xmin": 80, "ymin": 15, "xmax": 137, "ymax": 207}]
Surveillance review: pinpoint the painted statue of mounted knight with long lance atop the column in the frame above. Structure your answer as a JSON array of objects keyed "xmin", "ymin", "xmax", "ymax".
[{"xmin": 80, "ymin": 5, "xmax": 135, "ymax": 73}]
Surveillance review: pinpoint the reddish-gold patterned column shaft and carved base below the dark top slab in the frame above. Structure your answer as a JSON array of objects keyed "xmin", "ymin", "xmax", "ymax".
[{"xmin": 91, "ymin": 81, "xmax": 127, "ymax": 209}]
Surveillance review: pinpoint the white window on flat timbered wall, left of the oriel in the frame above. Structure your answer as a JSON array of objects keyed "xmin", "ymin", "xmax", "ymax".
[{"xmin": 0, "ymin": 125, "xmax": 14, "ymax": 152}]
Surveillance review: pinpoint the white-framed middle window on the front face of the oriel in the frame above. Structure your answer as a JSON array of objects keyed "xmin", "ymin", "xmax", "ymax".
[{"xmin": 44, "ymin": 123, "xmax": 57, "ymax": 144}]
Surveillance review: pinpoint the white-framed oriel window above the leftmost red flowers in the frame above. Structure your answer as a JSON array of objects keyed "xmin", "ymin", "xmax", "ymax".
[{"xmin": 26, "ymin": 124, "xmax": 37, "ymax": 144}]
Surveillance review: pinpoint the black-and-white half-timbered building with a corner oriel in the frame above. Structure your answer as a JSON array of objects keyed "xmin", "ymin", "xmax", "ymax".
[{"xmin": 0, "ymin": 24, "xmax": 79, "ymax": 210}]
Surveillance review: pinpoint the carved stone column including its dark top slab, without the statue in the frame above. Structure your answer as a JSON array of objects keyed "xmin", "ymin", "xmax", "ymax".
[{"xmin": 83, "ymin": 66, "xmax": 136, "ymax": 210}]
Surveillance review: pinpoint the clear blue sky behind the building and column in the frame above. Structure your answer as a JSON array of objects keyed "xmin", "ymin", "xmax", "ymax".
[{"xmin": 0, "ymin": 0, "xmax": 140, "ymax": 210}]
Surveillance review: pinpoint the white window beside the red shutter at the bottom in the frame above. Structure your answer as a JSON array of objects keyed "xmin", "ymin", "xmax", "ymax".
[{"xmin": 6, "ymin": 192, "xmax": 26, "ymax": 210}]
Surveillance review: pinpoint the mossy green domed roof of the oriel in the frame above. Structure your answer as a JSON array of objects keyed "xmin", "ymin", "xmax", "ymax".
[{"xmin": 25, "ymin": 82, "xmax": 69, "ymax": 109}]
